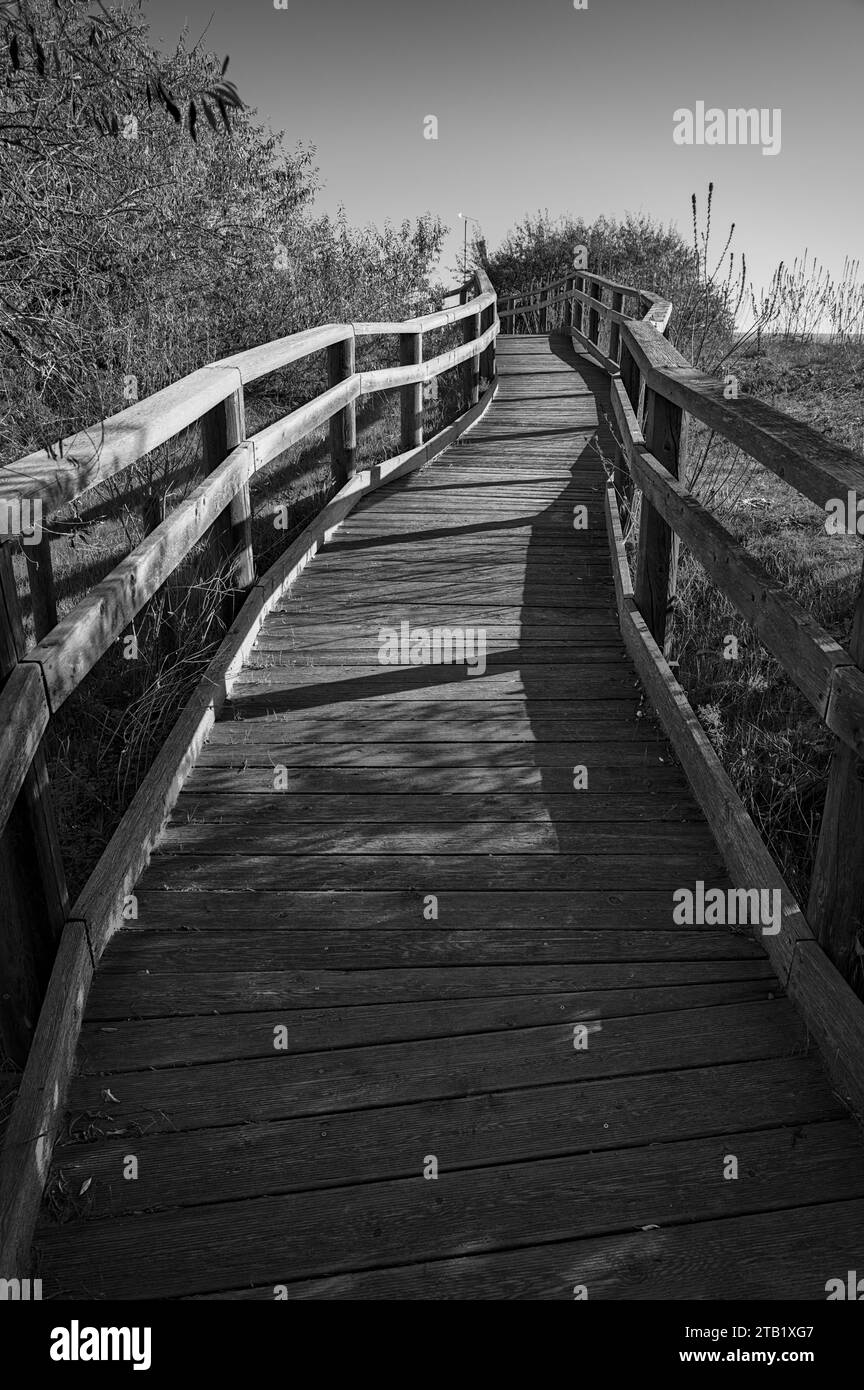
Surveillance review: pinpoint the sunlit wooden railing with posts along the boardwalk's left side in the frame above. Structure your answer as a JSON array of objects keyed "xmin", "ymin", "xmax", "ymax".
[{"xmin": 0, "ymin": 262, "xmax": 499, "ymax": 1063}]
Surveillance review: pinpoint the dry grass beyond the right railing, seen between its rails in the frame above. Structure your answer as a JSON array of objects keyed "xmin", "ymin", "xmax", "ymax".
[{"xmin": 672, "ymin": 341, "xmax": 864, "ymax": 978}]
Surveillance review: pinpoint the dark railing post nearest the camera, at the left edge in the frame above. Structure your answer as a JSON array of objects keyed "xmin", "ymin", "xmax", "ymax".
[{"xmin": 0, "ymin": 541, "xmax": 69, "ymax": 1066}]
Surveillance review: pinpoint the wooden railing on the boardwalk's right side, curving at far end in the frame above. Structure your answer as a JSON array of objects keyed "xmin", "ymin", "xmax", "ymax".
[{"xmin": 499, "ymin": 270, "xmax": 864, "ymax": 995}]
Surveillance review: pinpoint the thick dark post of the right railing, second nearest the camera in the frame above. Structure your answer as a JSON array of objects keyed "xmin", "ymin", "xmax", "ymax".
[{"xmin": 633, "ymin": 388, "xmax": 681, "ymax": 655}]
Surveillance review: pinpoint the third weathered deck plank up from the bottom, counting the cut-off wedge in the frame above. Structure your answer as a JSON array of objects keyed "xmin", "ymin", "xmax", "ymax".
[{"xmin": 42, "ymin": 1058, "xmax": 827, "ymax": 1223}]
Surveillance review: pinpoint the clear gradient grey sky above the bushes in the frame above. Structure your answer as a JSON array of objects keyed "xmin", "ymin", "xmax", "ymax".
[{"xmin": 144, "ymin": 0, "xmax": 864, "ymax": 296}]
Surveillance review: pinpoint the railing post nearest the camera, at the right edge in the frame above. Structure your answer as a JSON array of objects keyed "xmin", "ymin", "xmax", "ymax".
[{"xmin": 807, "ymin": 553, "xmax": 864, "ymax": 980}]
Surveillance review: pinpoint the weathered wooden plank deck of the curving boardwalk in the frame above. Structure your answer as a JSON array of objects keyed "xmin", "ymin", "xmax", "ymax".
[{"xmin": 36, "ymin": 338, "xmax": 864, "ymax": 1298}]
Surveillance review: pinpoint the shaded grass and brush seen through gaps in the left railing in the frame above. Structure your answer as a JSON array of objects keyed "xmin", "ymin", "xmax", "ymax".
[{"xmin": 15, "ymin": 334, "xmax": 469, "ymax": 901}]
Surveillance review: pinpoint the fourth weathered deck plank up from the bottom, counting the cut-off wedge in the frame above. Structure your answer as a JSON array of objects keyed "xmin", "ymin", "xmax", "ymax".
[{"xmin": 69, "ymin": 999, "xmax": 811, "ymax": 1145}]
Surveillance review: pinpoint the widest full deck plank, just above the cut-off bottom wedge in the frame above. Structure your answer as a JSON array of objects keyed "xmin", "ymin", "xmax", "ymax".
[{"xmin": 32, "ymin": 1120, "xmax": 864, "ymax": 1298}]
